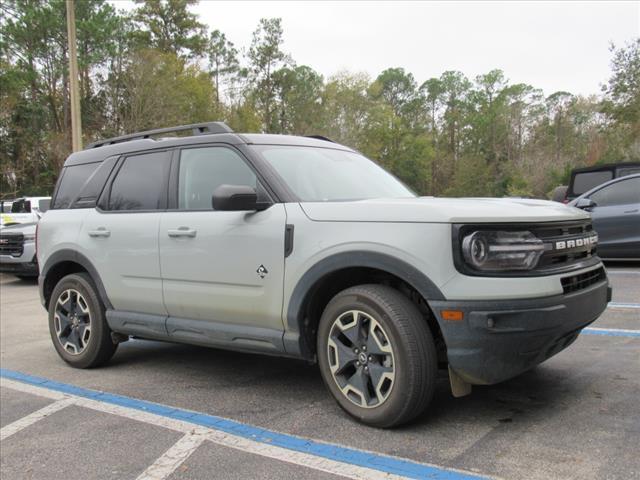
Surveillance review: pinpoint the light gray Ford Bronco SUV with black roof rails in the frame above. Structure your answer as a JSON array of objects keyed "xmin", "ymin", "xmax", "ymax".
[{"xmin": 37, "ymin": 122, "xmax": 611, "ymax": 427}]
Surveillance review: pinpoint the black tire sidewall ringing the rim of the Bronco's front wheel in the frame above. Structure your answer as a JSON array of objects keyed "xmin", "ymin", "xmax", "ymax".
[{"xmin": 317, "ymin": 293, "xmax": 418, "ymax": 426}]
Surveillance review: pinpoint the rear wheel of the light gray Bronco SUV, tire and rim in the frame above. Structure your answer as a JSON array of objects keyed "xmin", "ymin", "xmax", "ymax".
[{"xmin": 49, "ymin": 273, "xmax": 118, "ymax": 368}]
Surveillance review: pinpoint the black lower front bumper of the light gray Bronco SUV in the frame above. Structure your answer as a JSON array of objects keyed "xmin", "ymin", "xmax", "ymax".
[{"xmin": 430, "ymin": 278, "xmax": 611, "ymax": 385}]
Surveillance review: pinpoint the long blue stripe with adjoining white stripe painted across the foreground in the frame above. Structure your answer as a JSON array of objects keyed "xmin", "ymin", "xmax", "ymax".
[{"xmin": 0, "ymin": 369, "xmax": 490, "ymax": 480}]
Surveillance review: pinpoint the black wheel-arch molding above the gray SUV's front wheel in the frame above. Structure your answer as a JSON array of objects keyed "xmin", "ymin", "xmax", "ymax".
[{"xmin": 283, "ymin": 250, "xmax": 445, "ymax": 360}]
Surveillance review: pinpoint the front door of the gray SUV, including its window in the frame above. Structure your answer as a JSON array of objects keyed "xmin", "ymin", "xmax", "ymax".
[{"xmin": 160, "ymin": 146, "xmax": 286, "ymax": 349}]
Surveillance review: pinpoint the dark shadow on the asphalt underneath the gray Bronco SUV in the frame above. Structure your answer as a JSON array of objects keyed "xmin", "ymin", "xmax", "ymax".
[{"xmin": 100, "ymin": 339, "xmax": 583, "ymax": 431}]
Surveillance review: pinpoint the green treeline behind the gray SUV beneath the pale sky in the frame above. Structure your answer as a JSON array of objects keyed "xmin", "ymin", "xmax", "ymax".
[{"xmin": 0, "ymin": 0, "xmax": 640, "ymax": 197}]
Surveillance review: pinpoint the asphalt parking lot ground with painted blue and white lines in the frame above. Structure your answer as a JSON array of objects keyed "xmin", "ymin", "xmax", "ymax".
[{"xmin": 0, "ymin": 264, "xmax": 640, "ymax": 480}]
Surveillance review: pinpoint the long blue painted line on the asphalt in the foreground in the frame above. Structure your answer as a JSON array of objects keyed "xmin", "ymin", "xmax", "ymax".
[{"xmin": 0, "ymin": 368, "xmax": 488, "ymax": 480}]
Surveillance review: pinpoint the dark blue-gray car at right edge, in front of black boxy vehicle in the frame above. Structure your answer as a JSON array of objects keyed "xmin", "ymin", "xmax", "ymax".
[{"xmin": 569, "ymin": 174, "xmax": 640, "ymax": 260}]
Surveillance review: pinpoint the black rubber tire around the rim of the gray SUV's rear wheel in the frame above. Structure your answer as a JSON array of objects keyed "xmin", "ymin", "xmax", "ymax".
[{"xmin": 48, "ymin": 274, "xmax": 111, "ymax": 368}]
